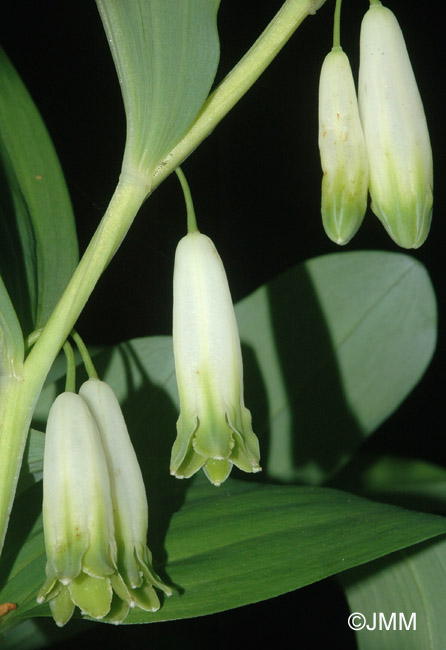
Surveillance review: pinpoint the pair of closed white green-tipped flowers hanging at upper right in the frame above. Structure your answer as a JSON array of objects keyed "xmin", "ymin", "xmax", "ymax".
[{"xmin": 319, "ymin": 0, "xmax": 433, "ymax": 248}]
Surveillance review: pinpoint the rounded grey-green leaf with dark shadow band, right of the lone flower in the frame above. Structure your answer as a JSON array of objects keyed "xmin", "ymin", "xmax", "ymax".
[{"xmin": 237, "ymin": 252, "xmax": 436, "ymax": 483}]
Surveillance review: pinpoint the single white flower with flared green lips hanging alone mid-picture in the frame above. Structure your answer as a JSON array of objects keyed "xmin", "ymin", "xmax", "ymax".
[{"xmin": 171, "ymin": 231, "xmax": 260, "ymax": 485}]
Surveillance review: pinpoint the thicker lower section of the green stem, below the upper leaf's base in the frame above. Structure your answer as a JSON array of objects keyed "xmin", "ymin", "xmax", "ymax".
[{"xmin": 0, "ymin": 178, "xmax": 147, "ymax": 552}]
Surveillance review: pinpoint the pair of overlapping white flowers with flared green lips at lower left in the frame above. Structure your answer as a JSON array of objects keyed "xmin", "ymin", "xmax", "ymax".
[{"xmin": 37, "ymin": 379, "xmax": 172, "ymax": 626}]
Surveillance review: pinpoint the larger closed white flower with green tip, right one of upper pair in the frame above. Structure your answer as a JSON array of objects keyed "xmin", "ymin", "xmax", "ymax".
[{"xmin": 359, "ymin": 3, "xmax": 433, "ymax": 248}]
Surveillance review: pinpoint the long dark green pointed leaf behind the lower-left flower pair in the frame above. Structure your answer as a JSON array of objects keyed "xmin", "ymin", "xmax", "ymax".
[{"xmin": 0, "ymin": 470, "xmax": 446, "ymax": 631}]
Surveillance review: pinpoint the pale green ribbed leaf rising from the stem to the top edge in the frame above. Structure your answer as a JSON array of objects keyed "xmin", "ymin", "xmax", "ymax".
[{"xmin": 97, "ymin": 0, "xmax": 220, "ymax": 180}]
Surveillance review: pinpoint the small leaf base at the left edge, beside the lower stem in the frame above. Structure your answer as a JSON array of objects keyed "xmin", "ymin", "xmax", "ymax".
[{"xmin": 0, "ymin": 276, "xmax": 24, "ymax": 374}]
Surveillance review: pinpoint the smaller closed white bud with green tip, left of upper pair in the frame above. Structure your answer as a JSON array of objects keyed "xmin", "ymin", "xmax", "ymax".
[{"xmin": 319, "ymin": 46, "xmax": 369, "ymax": 244}]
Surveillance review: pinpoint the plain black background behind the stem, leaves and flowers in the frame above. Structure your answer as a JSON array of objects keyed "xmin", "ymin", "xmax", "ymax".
[{"xmin": 0, "ymin": 0, "xmax": 446, "ymax": 650}]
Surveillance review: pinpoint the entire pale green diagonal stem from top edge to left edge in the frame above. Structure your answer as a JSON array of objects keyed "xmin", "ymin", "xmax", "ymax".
[{"xmin": 0, "ymin": 0, "xmax": 325, "ymax": 552}]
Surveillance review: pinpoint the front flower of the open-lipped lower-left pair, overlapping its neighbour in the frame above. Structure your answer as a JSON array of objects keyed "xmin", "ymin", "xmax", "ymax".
[{"xmin": 37, "ymin": 392, "xmax": 117, "ymax": 626}]
